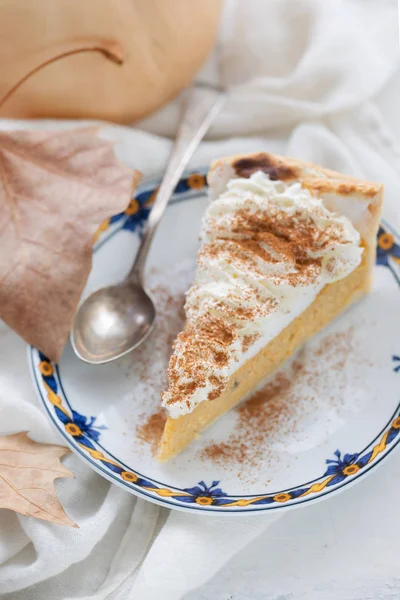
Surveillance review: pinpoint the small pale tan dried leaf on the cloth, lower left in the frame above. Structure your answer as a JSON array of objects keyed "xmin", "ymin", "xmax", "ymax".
[{"xmin": 0, "ymin": 431, "xmax": 78, "ymax": 527}]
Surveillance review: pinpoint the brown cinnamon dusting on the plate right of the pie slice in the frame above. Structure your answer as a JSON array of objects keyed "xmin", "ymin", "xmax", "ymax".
[{"xmin": 200, "ymin": 328, "xmax": 365, "ymax": 473}]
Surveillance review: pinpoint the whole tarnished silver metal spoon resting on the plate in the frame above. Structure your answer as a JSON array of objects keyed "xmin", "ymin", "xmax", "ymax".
[{"xmin": 71, "ymin": 87, "xmax": 225, "ymax": 365}]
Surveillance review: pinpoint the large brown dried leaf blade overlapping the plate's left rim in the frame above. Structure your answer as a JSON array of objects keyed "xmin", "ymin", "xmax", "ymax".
[{"xmin": 0, "ymin": 127, "xmax": 140, "ymax": 361}]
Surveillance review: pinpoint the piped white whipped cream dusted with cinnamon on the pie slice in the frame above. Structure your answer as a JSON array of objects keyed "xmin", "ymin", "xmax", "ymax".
[{"xmin": 162, "ymin": 171, "xmax": 363, "ymax": 418}]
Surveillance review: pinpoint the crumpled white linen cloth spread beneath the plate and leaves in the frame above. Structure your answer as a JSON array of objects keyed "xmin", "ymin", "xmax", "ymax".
[{"xmin": 0, "ymin": 0, "xmax": 400, "ymax": 600}]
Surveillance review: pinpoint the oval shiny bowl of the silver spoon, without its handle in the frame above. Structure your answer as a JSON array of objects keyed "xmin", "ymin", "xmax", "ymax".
[{"xmin": 71, "ymin": 281, "xmax": 156, "ymax": 365}]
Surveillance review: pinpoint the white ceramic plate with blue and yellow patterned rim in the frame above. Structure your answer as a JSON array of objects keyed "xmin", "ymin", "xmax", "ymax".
[{"xmin": 29, "ymin": 170, "xmax": 400, "ymax": 514}]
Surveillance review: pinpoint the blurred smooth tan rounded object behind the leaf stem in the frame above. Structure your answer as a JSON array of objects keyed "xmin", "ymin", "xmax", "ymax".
[{"xmin": 0, "ymin": 0, "xmax": 221, "ymax": 123}]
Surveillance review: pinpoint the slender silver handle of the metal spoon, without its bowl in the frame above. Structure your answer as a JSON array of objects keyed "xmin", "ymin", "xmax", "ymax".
[{"xmin": 128, "ymin": 87, "xmax": 225, "ymax": 287}]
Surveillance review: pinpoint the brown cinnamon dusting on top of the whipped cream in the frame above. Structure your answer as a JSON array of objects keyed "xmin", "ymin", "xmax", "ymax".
[{"xmin": 163, "ymin": 195, "xmax": 348, "ymax": 407}]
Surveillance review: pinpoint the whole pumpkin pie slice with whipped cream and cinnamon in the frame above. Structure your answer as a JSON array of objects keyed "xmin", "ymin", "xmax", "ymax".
[{"xmin": 158, "ymin": 153, "xmax": 383, "ymax": 460}]
